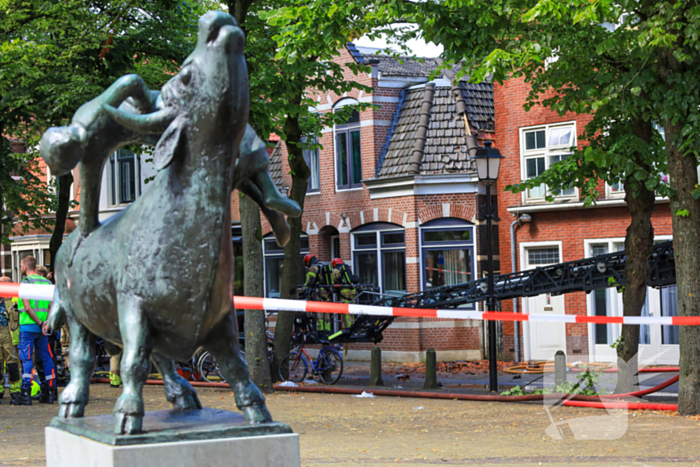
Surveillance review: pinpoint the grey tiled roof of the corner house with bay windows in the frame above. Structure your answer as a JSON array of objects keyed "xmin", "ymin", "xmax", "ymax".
[{"xmin": 377, "ymin": 82, "xmax": 495, "ymax": 178}]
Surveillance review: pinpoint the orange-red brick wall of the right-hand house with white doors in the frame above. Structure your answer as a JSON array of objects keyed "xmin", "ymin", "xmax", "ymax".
[{"xmin": 494, "ymin": 79, "xmax": 672, "ymax": 360}]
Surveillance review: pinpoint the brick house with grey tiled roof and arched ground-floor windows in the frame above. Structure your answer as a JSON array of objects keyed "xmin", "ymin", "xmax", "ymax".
[{"xmin": 232, "ymin": 44, "xmax": 495, "ymax": 361}]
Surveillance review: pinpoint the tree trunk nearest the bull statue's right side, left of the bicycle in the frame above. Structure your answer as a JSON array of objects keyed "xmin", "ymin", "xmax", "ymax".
[{"xmin": 240, "ymin": 195, "xmax": 273, "ymax": 393}]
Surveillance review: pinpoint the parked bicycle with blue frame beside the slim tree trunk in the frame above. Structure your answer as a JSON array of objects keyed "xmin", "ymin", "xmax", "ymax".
[{"xmin": 279, "ymin": 336, "xmax": 343, "ymax": 384}]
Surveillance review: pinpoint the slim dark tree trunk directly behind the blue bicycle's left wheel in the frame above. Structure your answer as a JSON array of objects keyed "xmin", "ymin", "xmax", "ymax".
[{"xmin": 272, "ymin": 100, "xmax": 310, "ymax": 381}]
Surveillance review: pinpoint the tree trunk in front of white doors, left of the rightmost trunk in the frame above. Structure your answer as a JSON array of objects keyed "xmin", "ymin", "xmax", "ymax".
[{"xmin": 615, "ymin": 118, "xmax": 656, "ymax": 393}]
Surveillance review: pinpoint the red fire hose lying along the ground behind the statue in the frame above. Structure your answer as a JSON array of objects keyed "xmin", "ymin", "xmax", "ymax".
[{"xmin": 92, "ymin": 376, "xmax": 679, "ymax": 411}]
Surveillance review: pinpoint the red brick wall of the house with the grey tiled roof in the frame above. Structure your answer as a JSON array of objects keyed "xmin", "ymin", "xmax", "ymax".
[{"xmin": 241, "ymin": 50, "xmax": 481, "ymax": 352}]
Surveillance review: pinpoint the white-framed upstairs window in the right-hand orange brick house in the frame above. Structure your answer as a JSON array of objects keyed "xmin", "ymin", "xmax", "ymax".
[{"xmin": 520, "ymin": 123, "xmax": 576, "ymax": 200}]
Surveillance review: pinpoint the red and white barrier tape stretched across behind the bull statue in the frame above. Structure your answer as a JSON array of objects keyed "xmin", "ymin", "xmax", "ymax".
[{"xmin": 0, "ymin": 282, "xmax": 700, "ymax": 326}]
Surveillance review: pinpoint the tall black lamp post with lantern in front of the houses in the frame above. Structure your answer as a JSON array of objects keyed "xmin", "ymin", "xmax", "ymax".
[{"xmin": 474, "ymin": 141, "xmax": 504, "ymax": 391}]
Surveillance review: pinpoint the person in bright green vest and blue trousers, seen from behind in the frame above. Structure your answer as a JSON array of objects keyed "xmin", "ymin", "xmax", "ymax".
[{"xmin": 12, "ymin": 256, "xmax": 56, "ymax": 405}]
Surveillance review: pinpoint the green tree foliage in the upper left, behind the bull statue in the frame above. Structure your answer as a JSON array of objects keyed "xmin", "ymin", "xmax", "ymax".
[{"xmin": 0, "ymin": 0, "xmax": 205, "ymax": 245}]
